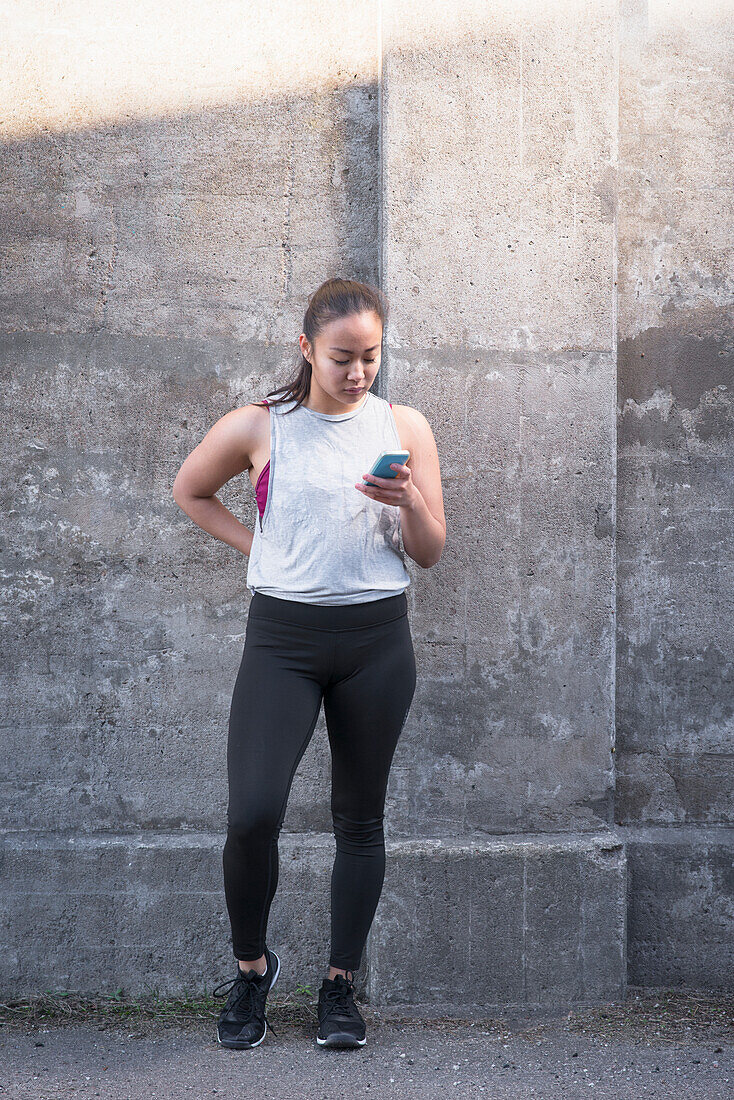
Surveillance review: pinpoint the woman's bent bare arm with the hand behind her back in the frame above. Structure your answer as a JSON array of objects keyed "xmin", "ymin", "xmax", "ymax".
[{"xmin": 173, "ymin": 405, "xmax": 267, "ymax": 554}]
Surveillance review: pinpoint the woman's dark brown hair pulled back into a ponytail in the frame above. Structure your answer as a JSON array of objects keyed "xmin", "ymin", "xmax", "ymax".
[{"xmin": 253, "ymin": 278, "xmax": 388, "ymax": 413}]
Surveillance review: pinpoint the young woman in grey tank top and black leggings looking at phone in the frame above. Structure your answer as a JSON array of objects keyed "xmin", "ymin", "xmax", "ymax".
[{"xmin": 173, "ymin": 279, "xmax": 446, "ymax": 1049}]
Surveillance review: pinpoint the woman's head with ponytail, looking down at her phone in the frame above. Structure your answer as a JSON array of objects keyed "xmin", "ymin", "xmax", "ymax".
[{"xmin": 259, "ymin": 278, "xmax": 388, "ymax": 408}]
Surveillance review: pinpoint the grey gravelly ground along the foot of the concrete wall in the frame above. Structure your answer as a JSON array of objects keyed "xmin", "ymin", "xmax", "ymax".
[{"xmin": 0, "ymin": 991, "xmax": 734, "ymax": 1100}]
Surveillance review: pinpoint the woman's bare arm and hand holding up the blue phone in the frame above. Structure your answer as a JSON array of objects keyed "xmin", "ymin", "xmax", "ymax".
[{"xmin": 355, "ymin": 405, "xmax": 446, "ymax": 569}]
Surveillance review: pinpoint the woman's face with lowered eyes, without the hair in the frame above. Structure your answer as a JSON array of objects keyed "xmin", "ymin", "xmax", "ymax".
[{"xmin": 300, "ymin": 310, "xmax": 382, "ymax": 405}]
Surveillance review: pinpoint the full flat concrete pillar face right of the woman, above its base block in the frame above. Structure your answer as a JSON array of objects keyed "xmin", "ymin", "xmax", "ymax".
[{"xmin": 382, "ymin": 0, "xmax": 616, "ymax": 835}]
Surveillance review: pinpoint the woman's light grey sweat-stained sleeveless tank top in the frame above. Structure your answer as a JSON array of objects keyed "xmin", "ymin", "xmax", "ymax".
[{"xmin": 245, "ymin": 391, "xmax": 410, "ymax": 604}]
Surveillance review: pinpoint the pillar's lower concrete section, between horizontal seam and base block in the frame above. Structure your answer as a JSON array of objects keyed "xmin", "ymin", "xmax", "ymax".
[{"xmin": 390, "ymin": 351, "xmax": 614, "ymax": 836}]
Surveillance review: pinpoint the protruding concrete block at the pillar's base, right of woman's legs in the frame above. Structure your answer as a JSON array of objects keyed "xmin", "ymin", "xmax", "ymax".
[{"xmin": 368, "ymin": 832, "xmax": 626, "ymax": 1011}]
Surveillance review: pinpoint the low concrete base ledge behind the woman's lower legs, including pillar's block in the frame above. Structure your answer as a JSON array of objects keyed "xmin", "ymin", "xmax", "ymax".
[{"xmin": 0, "ymin": 831, "xmax": 626, "ymax": 1010}]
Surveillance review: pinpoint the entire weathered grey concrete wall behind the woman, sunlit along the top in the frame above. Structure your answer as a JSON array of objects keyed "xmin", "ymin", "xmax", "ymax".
[{"xmin": 0, "ymin": 0, "xmax": 734, "ymax": 1010}]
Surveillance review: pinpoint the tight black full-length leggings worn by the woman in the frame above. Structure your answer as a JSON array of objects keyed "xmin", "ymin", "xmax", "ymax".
[{"xmin": 222, "ymin": 592, "xmax": 416, "ymax": 971}]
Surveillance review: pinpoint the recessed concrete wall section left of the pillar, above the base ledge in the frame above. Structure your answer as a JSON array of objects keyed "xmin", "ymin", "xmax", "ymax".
[{"xmin": 0, "ymin": 2, "xmax": 382, "ymax": 835}]
